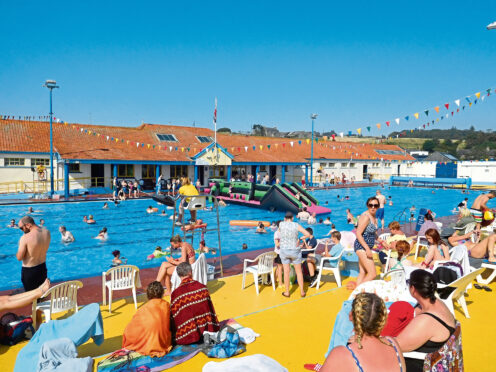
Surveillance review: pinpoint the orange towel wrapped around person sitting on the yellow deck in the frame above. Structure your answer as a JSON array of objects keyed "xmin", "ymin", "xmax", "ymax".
[{"xmin": 122, "ymin": 298, "xmax": 172, "ymax": 357}]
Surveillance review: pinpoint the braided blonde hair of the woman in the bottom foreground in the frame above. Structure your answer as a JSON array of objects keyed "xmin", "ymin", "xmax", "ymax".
[{"xmin": 351, "ymin": 293, "xmax": 391, "ymax": 349}]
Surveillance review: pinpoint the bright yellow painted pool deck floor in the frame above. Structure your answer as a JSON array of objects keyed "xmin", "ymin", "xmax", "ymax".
[{"xmin": 0, "ymin": 266, "xmax": 496, "ymax": 372}]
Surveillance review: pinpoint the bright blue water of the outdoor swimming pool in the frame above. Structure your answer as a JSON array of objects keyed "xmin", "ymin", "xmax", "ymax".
[{"xmin": 0, "ymin": 187, "xmax": 479, "ymax": 289}]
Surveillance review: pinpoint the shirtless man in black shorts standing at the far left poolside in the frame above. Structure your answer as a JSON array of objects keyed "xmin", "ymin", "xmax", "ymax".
[{"xmin": 16, "ymin": 216, "xmax": 50, "ymax": 292}]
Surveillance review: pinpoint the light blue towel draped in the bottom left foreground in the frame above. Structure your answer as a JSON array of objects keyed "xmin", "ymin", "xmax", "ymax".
[{"xmin": 14, "ymin": 304, "xmax": 103, "ymax": 372}]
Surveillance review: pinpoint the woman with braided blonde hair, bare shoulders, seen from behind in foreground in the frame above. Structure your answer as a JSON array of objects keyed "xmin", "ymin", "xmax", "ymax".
[{"xmin": 320, "ymin": 293, "xmax": 406, "ymax": 372}]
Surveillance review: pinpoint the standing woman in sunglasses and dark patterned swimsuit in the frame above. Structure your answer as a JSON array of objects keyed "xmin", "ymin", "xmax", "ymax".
[{"xmin": 353, "ymin": 196, "xmax": 380, "ymax": 286}]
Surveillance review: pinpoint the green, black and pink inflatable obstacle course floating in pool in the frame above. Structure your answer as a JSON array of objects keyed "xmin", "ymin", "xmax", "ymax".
[{"xmin": 210, "ymin": 179, "xmax": 331, "ymax": 214}]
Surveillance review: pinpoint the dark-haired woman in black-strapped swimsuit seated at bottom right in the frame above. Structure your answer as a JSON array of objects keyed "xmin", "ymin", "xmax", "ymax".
[{"xmin": 396, "ymin": 270, "xmax": 455, "ymax": 372}]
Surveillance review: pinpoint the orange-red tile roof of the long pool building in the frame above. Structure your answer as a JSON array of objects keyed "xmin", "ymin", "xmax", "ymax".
[{"xmin": 0, "ymin": 120, "xmax": 414, "ymax": 163}]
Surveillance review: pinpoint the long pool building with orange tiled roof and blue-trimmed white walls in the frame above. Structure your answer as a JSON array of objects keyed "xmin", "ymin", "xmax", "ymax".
[{"xmin": 0, "ymin": 119, "xmax": 415, "ymax": 196}]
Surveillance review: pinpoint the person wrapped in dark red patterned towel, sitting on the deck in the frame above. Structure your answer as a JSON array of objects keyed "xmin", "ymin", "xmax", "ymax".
[{"xmin": 171, "ymin": 262, "xmax": 219, "ymax": 345}]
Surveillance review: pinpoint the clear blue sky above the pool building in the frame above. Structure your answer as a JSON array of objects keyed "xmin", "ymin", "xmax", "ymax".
[{"xmin": 0, "ymin": 0, "xmax": 496, "ymax": 134}]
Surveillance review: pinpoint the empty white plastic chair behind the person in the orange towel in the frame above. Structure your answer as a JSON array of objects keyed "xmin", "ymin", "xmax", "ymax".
[{"xmin": 102, "ymin": 265, "xmax": 141, "ymax": 313}]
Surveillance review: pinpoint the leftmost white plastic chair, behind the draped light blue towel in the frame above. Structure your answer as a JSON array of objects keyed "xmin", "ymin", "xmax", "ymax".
[{"xmin": 32, "ymin": 280, "xmax": 83, "ymax": 329}]
